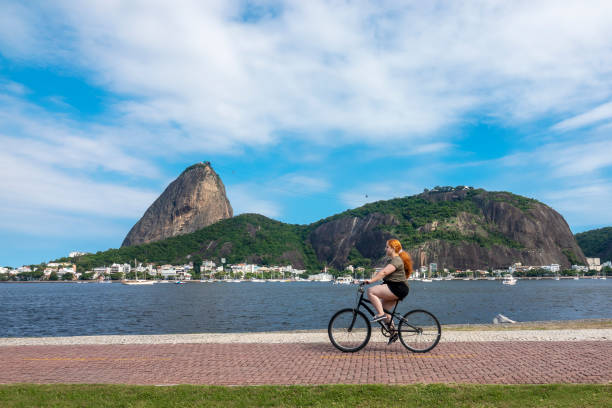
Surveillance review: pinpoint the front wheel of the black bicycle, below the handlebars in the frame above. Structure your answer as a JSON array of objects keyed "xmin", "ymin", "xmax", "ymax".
[{"xmin": 327, "ymin": 309, "xmax": 372, "ymax": 353}]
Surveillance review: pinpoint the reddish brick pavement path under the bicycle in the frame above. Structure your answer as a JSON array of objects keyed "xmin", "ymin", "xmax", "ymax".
[{"xmin": 0, "ymin": 341, "xmax": 612, "ymax": 385}]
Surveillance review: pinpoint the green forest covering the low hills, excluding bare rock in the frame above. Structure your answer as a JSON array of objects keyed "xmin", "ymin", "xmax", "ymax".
[{"xmin": 59, "ymin": 187, "xmax": 536, "ymax": 270}]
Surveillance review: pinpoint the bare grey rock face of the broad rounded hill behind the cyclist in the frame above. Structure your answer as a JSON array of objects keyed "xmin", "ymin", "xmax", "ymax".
[{"xmin": 309, "ymin": 190, "xmax": 586, "ymax": 269}]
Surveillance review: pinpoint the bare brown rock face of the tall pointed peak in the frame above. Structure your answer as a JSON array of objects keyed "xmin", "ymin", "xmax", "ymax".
[{"xmin": 121, "ymin": 162, "xmax": 233, "ymax": 246}]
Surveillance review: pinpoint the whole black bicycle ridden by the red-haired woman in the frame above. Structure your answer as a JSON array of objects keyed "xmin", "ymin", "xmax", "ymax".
[{"xmin": 327, "ymin": 283, "xmax": 442, "ymax": 353}]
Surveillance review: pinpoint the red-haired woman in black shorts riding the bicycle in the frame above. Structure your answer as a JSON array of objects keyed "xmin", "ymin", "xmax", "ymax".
[{"xmin": 365, "ymin": 239, "xmax": 412, "ymax": 344}]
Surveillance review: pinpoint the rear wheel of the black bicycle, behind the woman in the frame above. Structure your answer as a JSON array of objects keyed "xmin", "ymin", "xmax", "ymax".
[{"xmin": 398, "ymin": 310, "xmax": 442, "ymax": 353}]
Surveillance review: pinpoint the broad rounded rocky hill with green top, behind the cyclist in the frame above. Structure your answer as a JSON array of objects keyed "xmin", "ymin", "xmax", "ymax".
[{"xmin": 309, "ymin": 186, "xmax": 586, "ymax": 269}]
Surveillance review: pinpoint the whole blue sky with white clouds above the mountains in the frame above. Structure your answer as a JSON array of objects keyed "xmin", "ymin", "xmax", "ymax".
[{"xmin": 0, "ymin": 0, "xmax": 612, "ymax": 266}]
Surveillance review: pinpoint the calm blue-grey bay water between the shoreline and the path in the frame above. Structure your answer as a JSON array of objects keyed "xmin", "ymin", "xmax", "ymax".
[{"xmin": 0, "ymin": 279, "xmax": 612, "ymax": 337}]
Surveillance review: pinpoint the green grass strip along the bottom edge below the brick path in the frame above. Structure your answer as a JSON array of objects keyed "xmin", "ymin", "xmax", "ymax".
[{"xmin": 0, "ymin": 384, "xmax": 612, "ymax": 408}]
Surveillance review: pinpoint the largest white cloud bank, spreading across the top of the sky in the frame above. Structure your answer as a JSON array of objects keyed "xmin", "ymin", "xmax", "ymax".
[{"xmin": 0, "ymin": 0, "xmax": 612, "ymax": 152}]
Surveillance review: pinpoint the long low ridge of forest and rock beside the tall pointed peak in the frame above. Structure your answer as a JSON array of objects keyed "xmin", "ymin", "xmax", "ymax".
[{"xmin": 64, "ymin": 186, "xmax": 586, "ymax": 269}]
